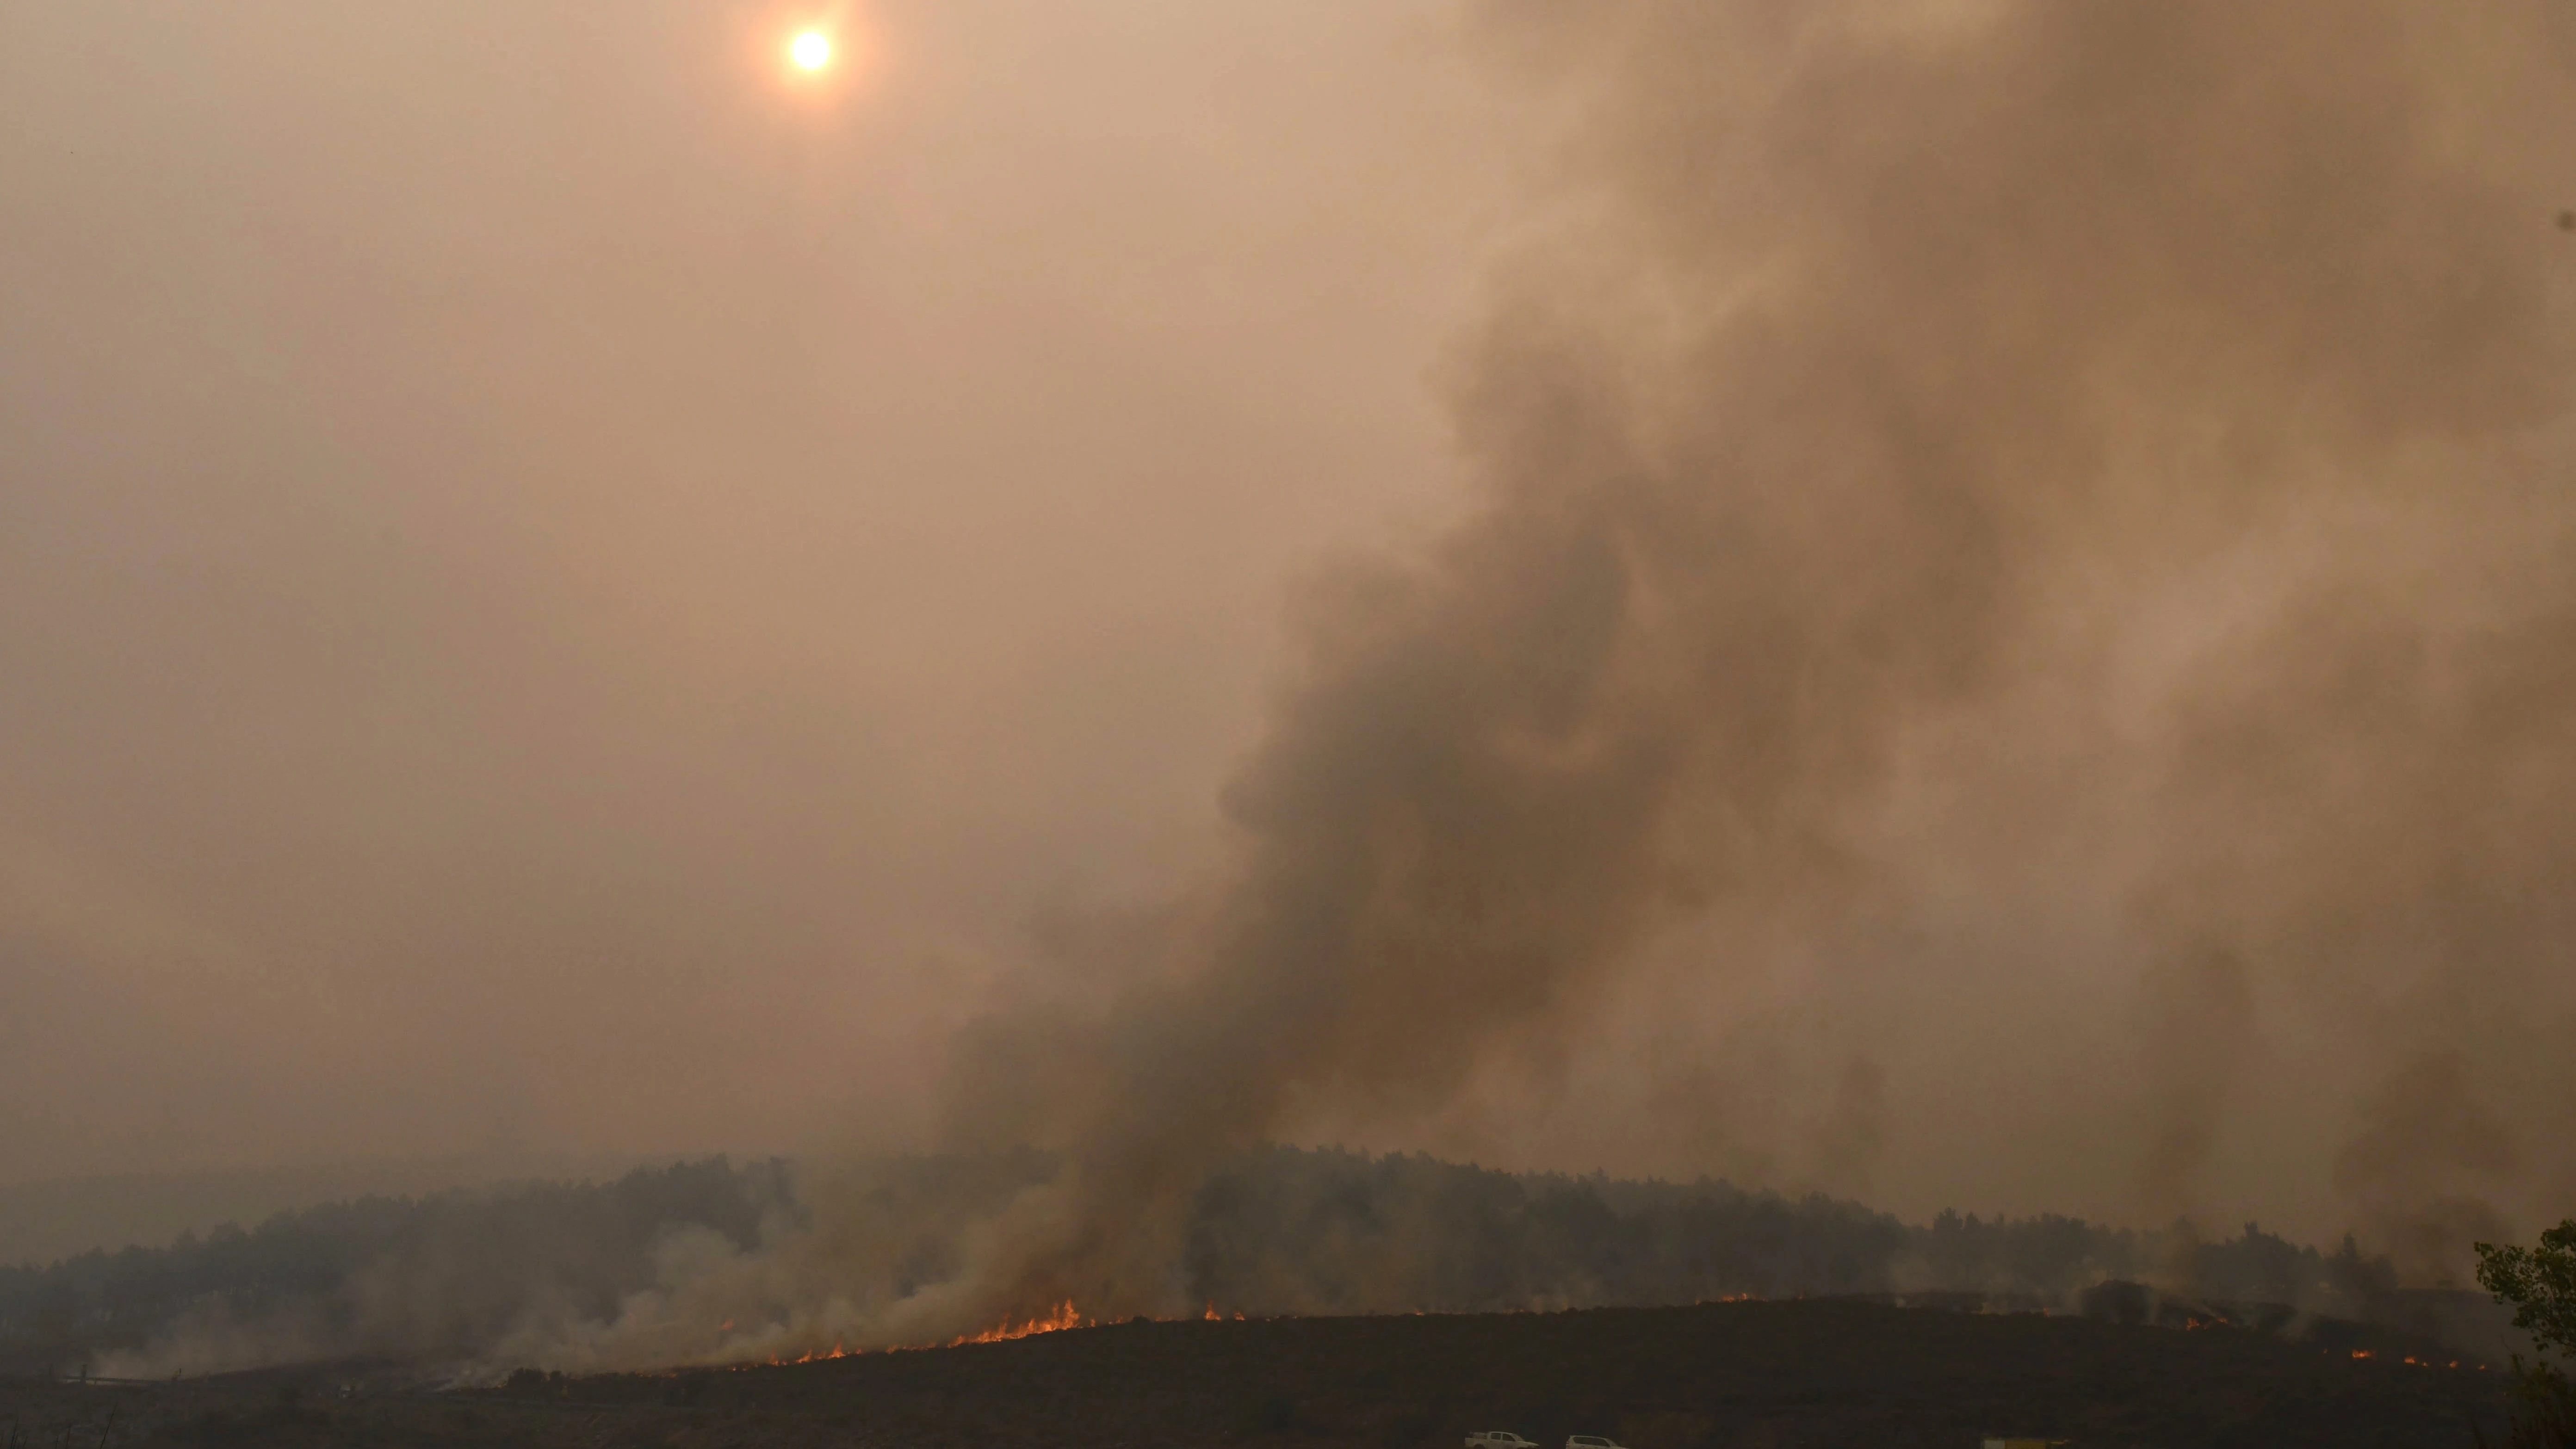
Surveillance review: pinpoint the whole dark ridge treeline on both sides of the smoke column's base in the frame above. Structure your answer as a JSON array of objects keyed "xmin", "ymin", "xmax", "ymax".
[{"xmin": 0, "ymin": 1147, "xmax": 2390, "ymax": 1369}]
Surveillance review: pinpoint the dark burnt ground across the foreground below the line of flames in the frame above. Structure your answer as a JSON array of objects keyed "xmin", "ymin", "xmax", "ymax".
[{"xmin": 0, "ymin": 1300, "xmax": 2504, "ymax": 1449}]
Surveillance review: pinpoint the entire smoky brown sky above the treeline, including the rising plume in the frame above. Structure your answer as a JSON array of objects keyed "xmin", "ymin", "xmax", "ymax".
[{"xmin": 0, "ymin": 0, "xmax": 2576, "ymax": 1263}]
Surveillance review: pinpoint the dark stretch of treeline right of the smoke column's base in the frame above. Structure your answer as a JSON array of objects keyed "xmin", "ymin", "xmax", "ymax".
[{"xmin": 1188, "ymin": 1147, "xmax": 2393, "ymax": 1313}]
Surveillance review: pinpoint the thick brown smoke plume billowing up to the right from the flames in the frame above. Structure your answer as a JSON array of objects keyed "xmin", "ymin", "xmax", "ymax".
[{"xmin": 938, "ymin": 0, "xmax": 2576, "ymax": 1323}]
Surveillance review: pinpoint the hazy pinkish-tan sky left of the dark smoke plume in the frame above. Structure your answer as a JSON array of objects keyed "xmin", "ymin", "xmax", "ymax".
[{"xmin": 0, "ymin": 0, "xmax": 1505, "ymax": 1178}]
